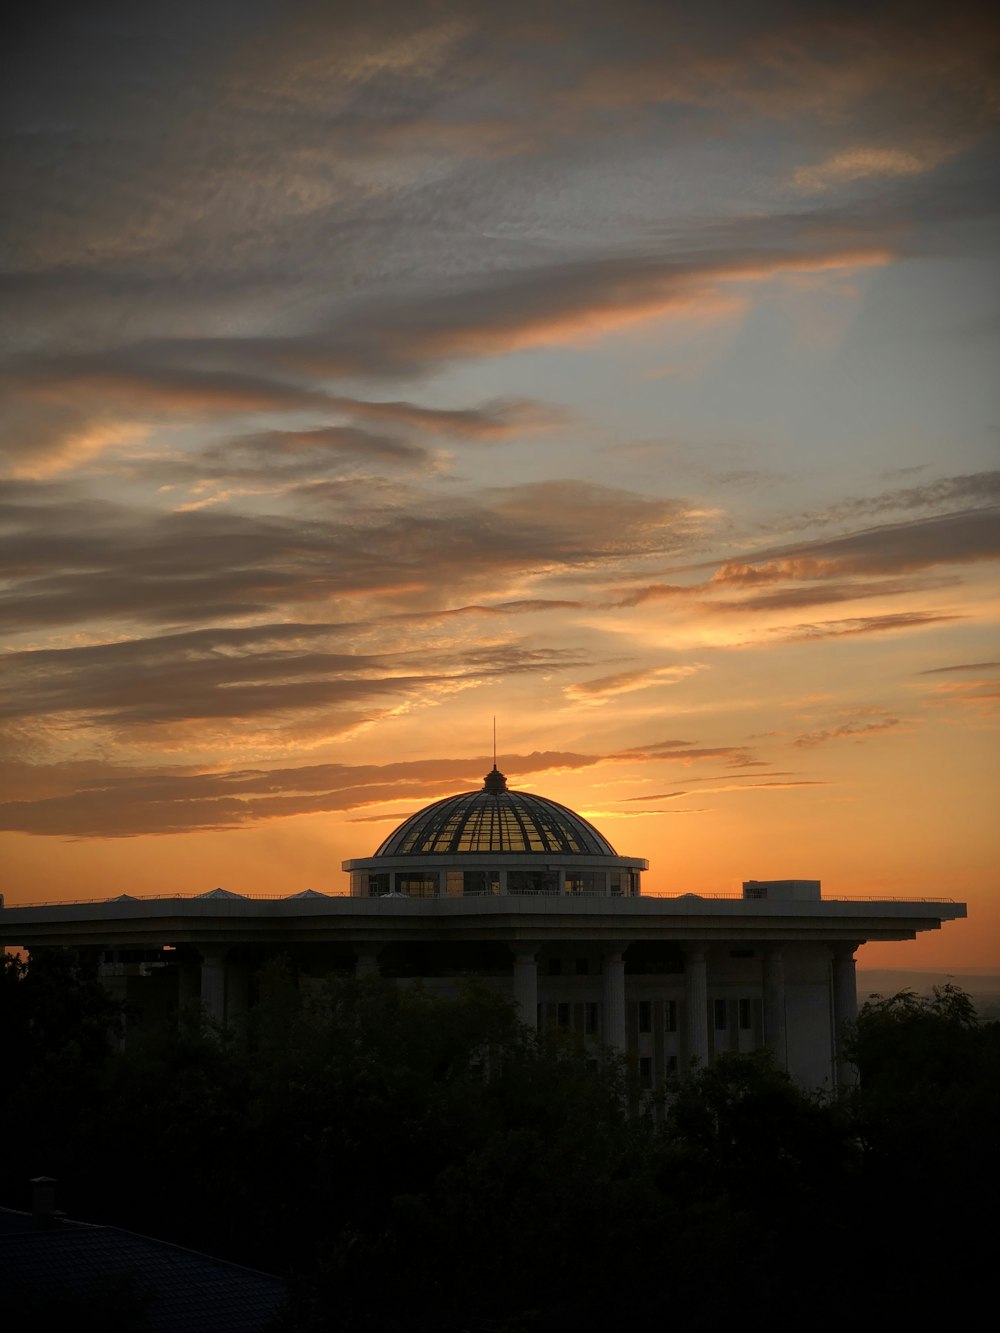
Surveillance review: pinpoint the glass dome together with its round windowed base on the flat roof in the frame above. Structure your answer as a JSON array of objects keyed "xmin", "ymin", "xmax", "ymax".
[{"xmin": 344, "ymin": 764, "xmax": 649, "ymax": 897}]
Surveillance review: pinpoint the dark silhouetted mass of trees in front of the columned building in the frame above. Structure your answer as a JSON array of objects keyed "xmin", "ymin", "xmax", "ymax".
[{"xmin": 0, "ymin": 950, "xmax": 1000, "ymax": 1333}]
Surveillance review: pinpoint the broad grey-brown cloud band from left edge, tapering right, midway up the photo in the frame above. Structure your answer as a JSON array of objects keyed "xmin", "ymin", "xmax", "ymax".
[{"xmin": 0, "ymin": 481, "xmax": 701, "ymax": 629}]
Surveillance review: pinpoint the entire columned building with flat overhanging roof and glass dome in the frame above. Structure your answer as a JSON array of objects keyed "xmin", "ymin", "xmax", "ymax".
[{"xmin": 0, "ymin": 766, "xmax": 965, "ymax": 1089}]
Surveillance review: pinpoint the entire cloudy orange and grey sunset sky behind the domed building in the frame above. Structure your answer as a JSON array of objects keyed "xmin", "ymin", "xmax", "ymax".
[{"xmin": 0, "ymin": 0, "xmax": 1000, "ymax": 968}]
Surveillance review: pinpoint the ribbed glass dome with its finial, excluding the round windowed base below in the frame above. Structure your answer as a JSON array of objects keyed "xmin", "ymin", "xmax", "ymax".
[{"xmin": 375, "ymin": 765, "xmax": 617, "ymax": 856}]
